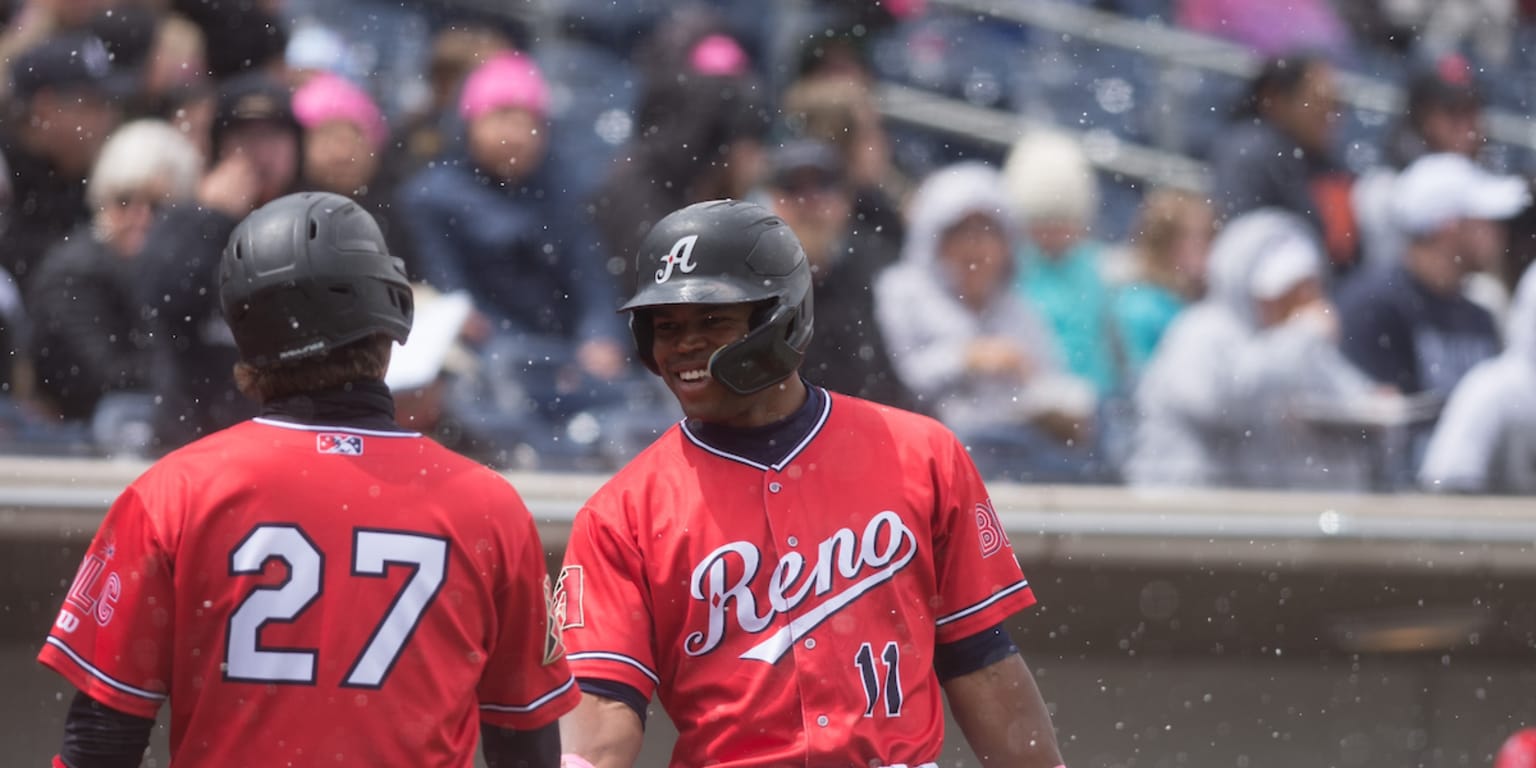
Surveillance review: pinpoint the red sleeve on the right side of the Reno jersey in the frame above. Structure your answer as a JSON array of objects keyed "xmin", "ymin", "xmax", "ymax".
[{"xmin": 934, "ymin": 436, "xmax": 1035, "ymax": 644}]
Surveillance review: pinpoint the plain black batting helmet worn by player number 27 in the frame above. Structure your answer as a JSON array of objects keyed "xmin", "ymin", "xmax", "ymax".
[{"xmin": 218, "ymin": 192, "xmax": 413, "ymax": 366}]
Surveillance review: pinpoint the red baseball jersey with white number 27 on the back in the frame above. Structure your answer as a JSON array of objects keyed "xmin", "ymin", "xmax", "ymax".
[{"xmin": 38, "ymin": 419, "xmax": 581, "ymax": 768}]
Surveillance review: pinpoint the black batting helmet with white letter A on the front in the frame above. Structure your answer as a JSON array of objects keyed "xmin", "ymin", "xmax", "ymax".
[{"xmin": 619, "ymin": 200, "xmax": 813, "ymax": 395}]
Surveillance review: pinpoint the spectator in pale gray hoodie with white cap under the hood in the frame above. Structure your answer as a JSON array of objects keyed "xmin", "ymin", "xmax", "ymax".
[{"xmin": 1126, "ymin": 209, "xmax": 1392, "ymax": 490}]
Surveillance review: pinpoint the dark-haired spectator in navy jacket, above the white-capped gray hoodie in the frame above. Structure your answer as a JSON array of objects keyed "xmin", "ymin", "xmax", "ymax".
[{"xmin": 1210, "ymin": 54, "xmax": 1358, "ymax": 270}]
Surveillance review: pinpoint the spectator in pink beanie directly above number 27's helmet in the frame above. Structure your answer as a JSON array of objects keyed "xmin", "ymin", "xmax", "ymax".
[{"xmin": 293, "ymin": 72, "xmax": 416, "ymax": 272}]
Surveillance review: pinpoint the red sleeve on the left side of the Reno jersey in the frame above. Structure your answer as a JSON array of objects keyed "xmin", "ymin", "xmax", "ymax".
[{"xmin": 556, "ymin": 507, "xmax": 660, "ymax": 699}]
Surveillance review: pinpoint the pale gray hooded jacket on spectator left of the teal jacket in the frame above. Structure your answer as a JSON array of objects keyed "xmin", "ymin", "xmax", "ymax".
[{"xmin": 874, "ymin": 163, "xmax": 1060, "ymax": 432}]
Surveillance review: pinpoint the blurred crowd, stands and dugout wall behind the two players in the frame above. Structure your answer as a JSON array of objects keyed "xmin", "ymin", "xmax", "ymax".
[{"xmin": 0, "ymin": 0, "xmax": 1536, "ymax": 768}]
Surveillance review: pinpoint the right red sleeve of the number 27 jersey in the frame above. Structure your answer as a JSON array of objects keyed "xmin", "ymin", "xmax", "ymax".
[{"xmin": 476, "ymin": 491, "xmax": 581, "ymax": 731}]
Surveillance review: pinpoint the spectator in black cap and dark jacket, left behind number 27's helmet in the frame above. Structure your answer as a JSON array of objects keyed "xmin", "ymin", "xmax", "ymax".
[{"xmin": 137, "ymin": 72, "xmax": 303, "ymax": 450}]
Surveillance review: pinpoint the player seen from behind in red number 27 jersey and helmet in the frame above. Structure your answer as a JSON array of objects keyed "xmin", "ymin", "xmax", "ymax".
[{"xmin": 38, "ymin": 194, "xmax": 581, "ymax": 768}]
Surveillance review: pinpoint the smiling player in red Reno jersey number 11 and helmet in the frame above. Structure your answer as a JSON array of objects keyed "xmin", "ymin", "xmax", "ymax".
[{"xmin": 556, "ymin": 201, "xmax": 1061, "ymax": 768}]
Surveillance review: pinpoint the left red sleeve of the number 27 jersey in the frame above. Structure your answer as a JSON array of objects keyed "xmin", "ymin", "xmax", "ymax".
[{"xmin": 37, "ymin": 487, "xmax": 175, "ymax": 719}]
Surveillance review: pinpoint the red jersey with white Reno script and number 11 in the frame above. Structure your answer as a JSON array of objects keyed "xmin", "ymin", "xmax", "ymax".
[{"xmin": 554, "ymin": 395, "xmax": 1034, "ymax": 766}]
